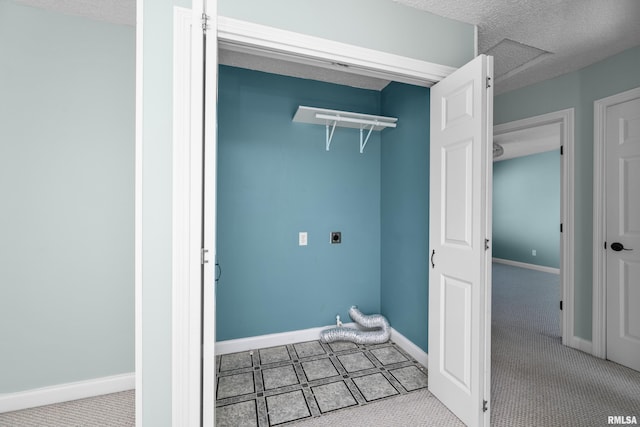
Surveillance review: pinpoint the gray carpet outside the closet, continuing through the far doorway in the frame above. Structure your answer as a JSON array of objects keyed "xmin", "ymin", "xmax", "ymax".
[{"xmin": 0, "ymin": 264, "xmax": 640, "ymax": 427}]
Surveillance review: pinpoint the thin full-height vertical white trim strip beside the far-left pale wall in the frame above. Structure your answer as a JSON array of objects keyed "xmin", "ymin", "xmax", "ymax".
[{"xmin": 134, "ymin": 0, "xmax": 144, "ymax": 426}]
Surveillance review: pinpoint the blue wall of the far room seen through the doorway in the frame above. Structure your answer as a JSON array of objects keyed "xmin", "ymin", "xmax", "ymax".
[{"xmin": 493, "ymin": 150, "xmax": 560, "ymax": 268}]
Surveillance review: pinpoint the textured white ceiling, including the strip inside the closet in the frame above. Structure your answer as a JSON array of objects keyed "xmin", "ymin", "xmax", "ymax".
[{"xmin": 16, "ymin": 0, "xmax": 640, "ymax": 94}]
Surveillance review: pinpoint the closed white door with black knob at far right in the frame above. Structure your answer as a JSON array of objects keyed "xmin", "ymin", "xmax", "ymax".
[{"xmin": 604, "ymin": 91, "xmax": 640, "ymax": 371}]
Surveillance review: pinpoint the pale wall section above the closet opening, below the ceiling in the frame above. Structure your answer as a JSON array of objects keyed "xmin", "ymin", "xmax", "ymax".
[{"xmin": 218, "ymin": 0, "xmax": 475, "ymax": 67}]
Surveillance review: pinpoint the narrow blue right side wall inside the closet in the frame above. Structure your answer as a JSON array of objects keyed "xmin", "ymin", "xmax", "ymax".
[{"xmin": 380, "ymin": 83, "xmax": 429, "ymax": 351}]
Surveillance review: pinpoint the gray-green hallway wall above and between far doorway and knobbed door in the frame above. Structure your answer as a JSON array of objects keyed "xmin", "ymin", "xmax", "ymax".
[{"xmin": 494, "ymin": 46, "xmax": 640, "ymax": 340}]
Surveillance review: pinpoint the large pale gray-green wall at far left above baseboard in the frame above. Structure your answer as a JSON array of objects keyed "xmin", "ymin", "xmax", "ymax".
[{"xmin": 0, "ymin": 0, "xmax": 135, "ymax": 393}]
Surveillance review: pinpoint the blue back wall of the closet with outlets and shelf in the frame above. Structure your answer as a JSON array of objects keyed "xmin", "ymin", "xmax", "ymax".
[{"xmin": 216, "ymin": 66, "xmax": 381, "ymax": 341}]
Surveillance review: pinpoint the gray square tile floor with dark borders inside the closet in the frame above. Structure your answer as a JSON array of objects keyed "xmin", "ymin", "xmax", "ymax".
[{"xmin": 216, "ymin": 341, "xmax": 427, "ymax": 427}]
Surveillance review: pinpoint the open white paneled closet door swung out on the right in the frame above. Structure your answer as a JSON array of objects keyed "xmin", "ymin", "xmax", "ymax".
[{"xmin": 429, "ymin": 55, "xmax": 493, "ymax": 426}]
